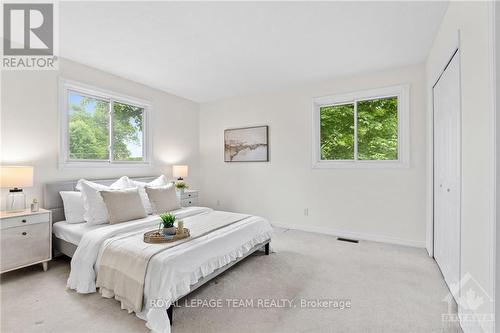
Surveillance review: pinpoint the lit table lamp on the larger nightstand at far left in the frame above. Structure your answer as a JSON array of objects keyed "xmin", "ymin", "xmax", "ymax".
[{"xmin": 0, "ymin": 165, "xmax": 33, "ymax": 213}]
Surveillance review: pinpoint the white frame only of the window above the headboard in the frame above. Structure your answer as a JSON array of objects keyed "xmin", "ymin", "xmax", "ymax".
[{"xmin": 59, "ymin": 79, "xmax": 152, "ymax": 168}]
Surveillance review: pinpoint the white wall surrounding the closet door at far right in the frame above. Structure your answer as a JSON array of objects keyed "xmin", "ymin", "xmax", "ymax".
[{"xmin": 426, "ymin": 2, "xmax": 495, "ymax": 332}]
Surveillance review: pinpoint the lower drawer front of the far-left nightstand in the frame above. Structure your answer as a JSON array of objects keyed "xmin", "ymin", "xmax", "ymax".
[{"xmin": 1, "ymin": 222, "xmax": 51, "ymax": 272}]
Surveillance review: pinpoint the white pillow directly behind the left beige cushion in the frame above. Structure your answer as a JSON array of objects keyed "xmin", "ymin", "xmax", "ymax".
[{"xmin": 76, "ymin": 176, "xmax": 131, "ymax": 225}]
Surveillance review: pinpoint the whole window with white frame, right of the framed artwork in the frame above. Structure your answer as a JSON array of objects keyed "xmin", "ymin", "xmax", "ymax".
[{"xmin": 313, "ymin": 86, "xmax": 409, "ymax": 168}]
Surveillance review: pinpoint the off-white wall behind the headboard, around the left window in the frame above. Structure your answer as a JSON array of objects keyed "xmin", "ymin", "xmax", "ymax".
[{"xmin": 0, "ymin": 59, "xmax": 199, "ymax": 209}]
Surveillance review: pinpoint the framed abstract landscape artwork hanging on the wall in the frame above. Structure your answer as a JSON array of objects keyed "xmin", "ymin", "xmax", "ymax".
[{"xmin": 224, "ymin": 126, "xmax": 269, "ymax": 162}]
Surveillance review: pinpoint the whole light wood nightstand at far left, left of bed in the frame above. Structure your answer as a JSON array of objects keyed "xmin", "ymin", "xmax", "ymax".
[{"xmin": 0, "ymin": 209, "xmax": 52, "ymax": 273}]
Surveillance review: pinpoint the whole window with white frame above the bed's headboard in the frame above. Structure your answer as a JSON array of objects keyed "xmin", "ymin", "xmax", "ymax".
[{"xmin": 60, "ymin": 81, "xmax": 150, "ymax": 166}]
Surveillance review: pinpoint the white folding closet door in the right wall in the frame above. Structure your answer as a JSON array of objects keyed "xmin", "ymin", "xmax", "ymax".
[{"xmin": 433, "ymin": 52, "xmax": 461, "ymax": 286}]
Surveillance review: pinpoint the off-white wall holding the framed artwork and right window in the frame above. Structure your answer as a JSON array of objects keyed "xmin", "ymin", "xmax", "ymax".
[{"xmin": 200, "ymin": 65, "xmax": 426, "ymax": 246}]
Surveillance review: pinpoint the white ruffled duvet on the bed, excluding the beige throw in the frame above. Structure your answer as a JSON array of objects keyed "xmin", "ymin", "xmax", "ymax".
[{"xmin": 67, "ymin": 207, "xmax": 272, "ymax": 333}]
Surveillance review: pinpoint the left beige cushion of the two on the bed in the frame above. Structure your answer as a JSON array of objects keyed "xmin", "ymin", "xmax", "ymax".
[{"xmin": 99, "ymin": 188, "xmax": 147, "ymax": 224}]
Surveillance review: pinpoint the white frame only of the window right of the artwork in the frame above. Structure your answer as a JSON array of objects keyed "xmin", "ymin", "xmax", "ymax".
[{"xmin": 312, "ymin": 84, "xmax": 410, "ymax": 169}]
